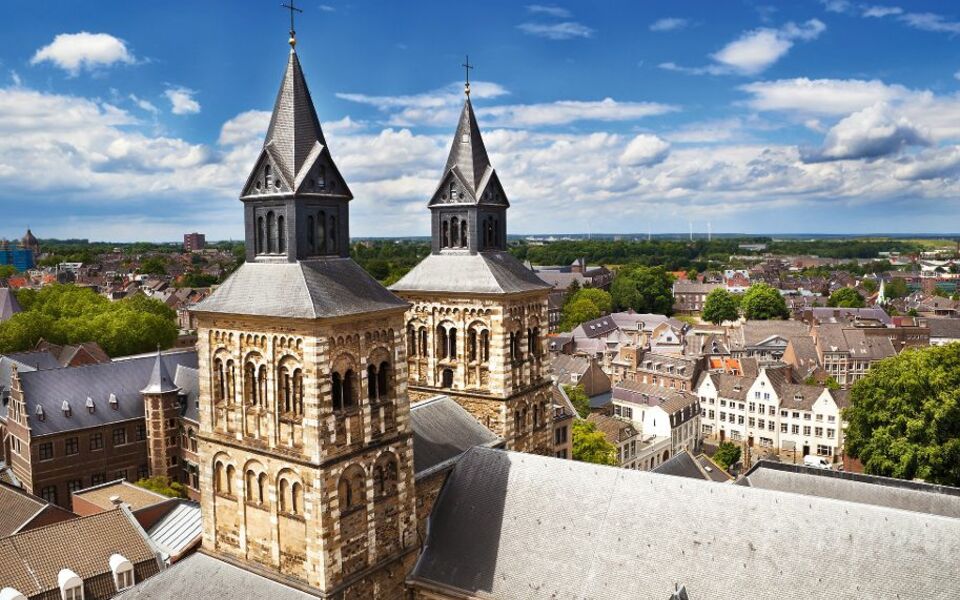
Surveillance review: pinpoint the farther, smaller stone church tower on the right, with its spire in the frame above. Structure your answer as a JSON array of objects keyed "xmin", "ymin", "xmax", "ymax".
[{"xmin": 391, "ymin": 84, "xmax": 553, "ymax": 455}]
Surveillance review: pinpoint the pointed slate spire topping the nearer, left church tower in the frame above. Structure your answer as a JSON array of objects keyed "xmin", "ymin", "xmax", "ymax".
[{"xmin": 263, "ymin": 48, "xmax": 327, "ymax": 187}]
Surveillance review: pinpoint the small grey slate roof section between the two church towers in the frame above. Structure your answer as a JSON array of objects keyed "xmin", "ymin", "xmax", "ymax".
[{"xmin": 410, "ymin": 396, "xmax": 503, "ymax": 474}]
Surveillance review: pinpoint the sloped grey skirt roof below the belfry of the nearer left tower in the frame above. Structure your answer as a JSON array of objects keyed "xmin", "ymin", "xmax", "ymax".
[{"xmin": 193, "ymin": 258, "xmax": 407, "ymax": 319}]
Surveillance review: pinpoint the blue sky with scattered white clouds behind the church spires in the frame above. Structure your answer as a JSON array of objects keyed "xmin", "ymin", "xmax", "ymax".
[{"xmin": 0, "ymin": 0, "xmax": 960, "ymax": 241}]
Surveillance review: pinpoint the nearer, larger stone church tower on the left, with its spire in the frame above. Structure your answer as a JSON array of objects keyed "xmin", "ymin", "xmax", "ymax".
[{"xmin": 194, "ymin": 22, "xmax": 416, "ymax": 599}]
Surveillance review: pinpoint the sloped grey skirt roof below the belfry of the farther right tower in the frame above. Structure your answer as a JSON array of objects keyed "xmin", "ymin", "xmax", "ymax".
[{"xmin": 390, "ymin": 251, "xmax": 550, "ymax": 294}]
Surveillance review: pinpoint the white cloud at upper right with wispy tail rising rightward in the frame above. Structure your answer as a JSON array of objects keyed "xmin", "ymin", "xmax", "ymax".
[{"xmin": 711, "ymin": 19, "xmax": 827, "ymax": 75}]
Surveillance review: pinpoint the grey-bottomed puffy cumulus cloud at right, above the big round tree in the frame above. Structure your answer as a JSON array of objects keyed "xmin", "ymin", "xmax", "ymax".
[{"xmin": 804, "ymin": 103, "xmax": 932, "ymax": 162}]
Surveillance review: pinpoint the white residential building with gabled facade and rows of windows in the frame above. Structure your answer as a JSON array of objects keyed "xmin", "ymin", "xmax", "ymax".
[{"xmin": 697, "ymin": 368, "xmax": 846, "ymax": 460}]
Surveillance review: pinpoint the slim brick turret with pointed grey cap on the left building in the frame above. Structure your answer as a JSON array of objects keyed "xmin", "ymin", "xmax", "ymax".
[{"xmin": 140, "ymin": 348, "xmax": 180, "ymax": 480}]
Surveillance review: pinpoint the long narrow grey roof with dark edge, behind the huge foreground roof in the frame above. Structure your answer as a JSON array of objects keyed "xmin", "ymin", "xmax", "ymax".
[{"xmin": 737, "ymin": 461, "xmax": 960, "ymax": 519}]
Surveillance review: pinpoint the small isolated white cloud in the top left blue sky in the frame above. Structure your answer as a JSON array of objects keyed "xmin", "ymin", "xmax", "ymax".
[{"xmin": 30, "ymin": 31, "xmax": 136, "ymax": 75}]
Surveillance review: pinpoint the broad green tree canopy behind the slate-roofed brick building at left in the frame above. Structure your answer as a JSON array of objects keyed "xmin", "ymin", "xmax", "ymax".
[{"xmin": 0, "ymin": 285, "xmax": 177, "ymax": 356}]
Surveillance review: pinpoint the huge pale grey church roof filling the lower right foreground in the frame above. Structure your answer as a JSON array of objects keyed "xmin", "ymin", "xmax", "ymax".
[{"xmin": 410, "ymin": 448, "xmax": 960, "ymax": 600}]
